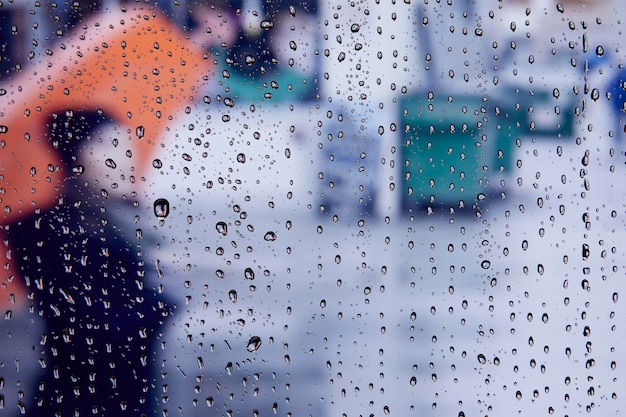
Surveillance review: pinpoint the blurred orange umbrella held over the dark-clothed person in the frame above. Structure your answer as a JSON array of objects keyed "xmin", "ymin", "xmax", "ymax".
[{"xmin": 0, "ymin": 5, "xmax": 210, "ymax": 304}]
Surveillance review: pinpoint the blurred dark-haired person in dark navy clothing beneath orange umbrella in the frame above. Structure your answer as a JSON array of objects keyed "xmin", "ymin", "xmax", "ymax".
[{"xmin": 8, "ymin": 113, "xmax": 170, "ymax": 416}]
